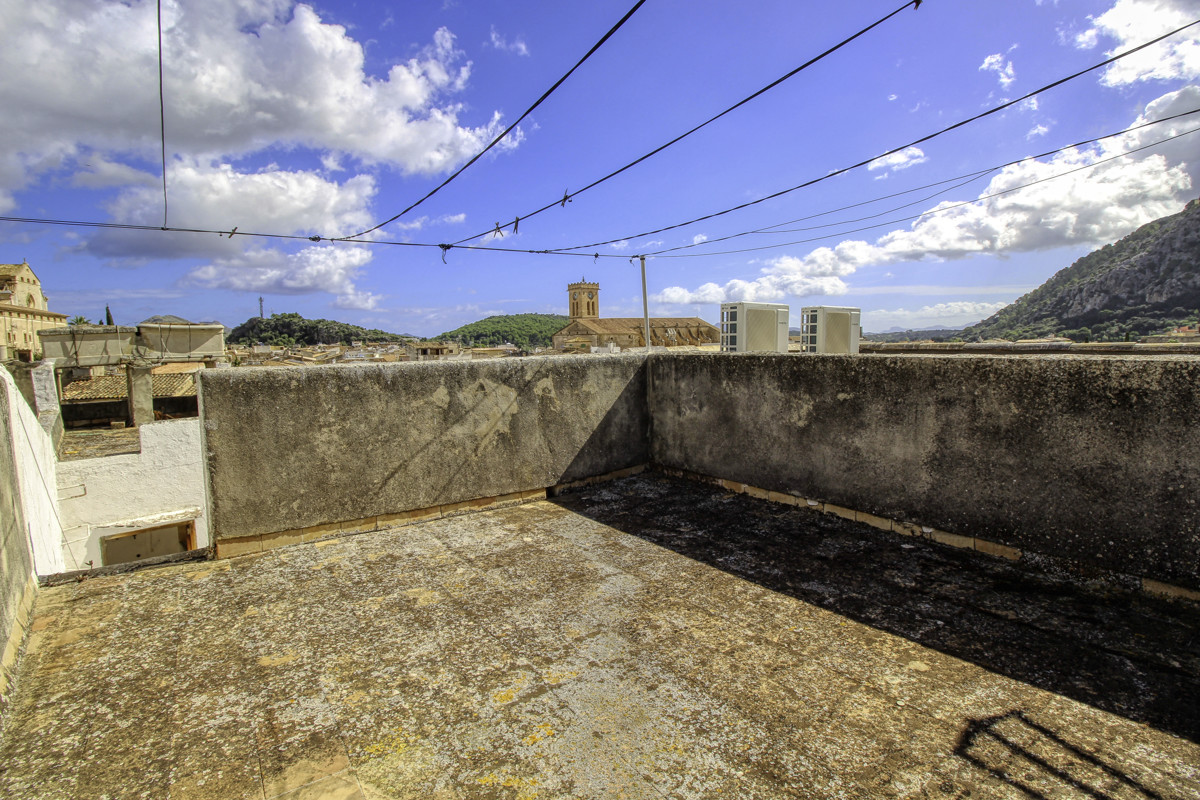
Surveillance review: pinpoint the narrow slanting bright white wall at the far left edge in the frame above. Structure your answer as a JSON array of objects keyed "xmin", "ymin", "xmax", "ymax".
[{"xmin": 0, "ymin": 367, "xmax": 66, "ymax": 575}]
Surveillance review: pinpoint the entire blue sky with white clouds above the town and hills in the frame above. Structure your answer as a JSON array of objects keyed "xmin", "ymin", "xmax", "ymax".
[{"xmin": 0, "ymin": 0, "xmax": 1200, "ymax": 336}]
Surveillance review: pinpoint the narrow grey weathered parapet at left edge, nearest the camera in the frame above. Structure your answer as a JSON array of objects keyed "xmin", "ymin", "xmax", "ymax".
[{"xmin": 0, "ymin": 369, "xmax": 37, "ymax": 710}]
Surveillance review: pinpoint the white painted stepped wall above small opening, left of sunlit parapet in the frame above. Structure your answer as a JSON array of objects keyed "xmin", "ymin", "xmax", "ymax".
[{"xmin": 58, "ymin": 417, "xmax": 209, "ymax": 570}]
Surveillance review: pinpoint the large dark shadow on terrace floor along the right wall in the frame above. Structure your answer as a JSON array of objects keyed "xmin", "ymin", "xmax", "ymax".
[{"xmin": 554, "ymin": 474, "xmax": 1200, "ymax": 743}]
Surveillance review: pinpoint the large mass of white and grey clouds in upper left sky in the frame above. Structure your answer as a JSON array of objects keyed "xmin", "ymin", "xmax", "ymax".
[{"xmin": 0, "ymin": 0, "xmax": 523, "ymax": 306}]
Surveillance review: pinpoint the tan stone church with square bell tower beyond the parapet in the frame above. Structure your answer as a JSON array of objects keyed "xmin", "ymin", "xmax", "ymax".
[{"xmin": 551, "ymin": 279, "xmax": 721, "ymax": 353}]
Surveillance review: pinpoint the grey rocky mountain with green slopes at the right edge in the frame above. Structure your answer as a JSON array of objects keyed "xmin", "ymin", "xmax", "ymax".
[{"xmin": 961, "ymin": 200, "xmax": 1200, "ymax": 342}]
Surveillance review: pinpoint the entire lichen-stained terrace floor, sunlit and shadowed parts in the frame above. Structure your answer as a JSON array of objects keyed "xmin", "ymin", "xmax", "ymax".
[{"xmin": 0, "ymin": 476, "xmax": 1200, "ymax": 800}]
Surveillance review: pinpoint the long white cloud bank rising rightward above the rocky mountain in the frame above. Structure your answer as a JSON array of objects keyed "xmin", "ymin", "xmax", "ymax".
[{"xmin": 658, "ymin": 86, "xmax": 1200, "ymax": 303}]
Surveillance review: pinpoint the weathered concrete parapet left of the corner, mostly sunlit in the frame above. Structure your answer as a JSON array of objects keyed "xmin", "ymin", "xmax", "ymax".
[{"xmin": 199, "ymin": 355, "xmax": 649, "ymax": 541}]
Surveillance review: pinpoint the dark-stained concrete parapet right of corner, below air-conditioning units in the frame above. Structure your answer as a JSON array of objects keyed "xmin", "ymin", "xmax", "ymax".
[{"xmin": 650, "ymin": 355, "xmax": 1200, "ymax": 589}]
